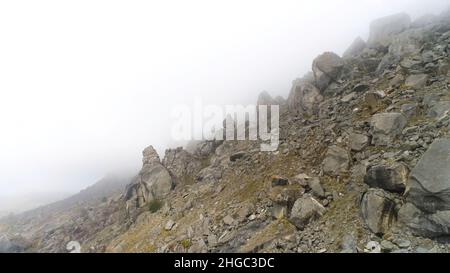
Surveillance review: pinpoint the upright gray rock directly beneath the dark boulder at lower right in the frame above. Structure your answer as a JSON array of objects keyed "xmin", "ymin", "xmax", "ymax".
[{"xmin": 360, "ymin": 189, "xmax": 396, "ymax": 235}]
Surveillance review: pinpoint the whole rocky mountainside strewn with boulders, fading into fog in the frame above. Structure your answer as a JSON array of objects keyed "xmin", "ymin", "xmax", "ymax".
[{"xmin": 0, "ymin": 11, "xmax": 450, "ymax": 253}]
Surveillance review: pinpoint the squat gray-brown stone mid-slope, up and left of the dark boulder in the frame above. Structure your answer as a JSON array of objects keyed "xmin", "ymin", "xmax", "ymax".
[{"xmin": 322, "ymin": 145, "xmax": 350, "ymax": 175}]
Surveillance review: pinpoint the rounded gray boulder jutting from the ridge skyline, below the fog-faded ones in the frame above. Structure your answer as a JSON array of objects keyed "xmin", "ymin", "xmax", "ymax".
[{"xmin": 312, "ymin": 52, "xmax": 344, "ymax": 91}]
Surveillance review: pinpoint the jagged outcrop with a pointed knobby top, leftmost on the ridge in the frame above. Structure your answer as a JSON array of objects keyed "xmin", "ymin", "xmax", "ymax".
[{"xmin": 125, "ymin": 146, "xmax": 174, "ymax": 210}]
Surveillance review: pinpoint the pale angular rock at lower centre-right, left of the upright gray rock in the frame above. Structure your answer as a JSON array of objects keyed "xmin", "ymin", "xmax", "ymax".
[{"xmin": 289, "ymin": 196, "xmax": 326, "ymax": 230}]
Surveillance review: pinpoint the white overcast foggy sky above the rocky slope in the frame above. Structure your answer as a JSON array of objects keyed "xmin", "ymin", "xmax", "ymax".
[{"xmin": 0, "ymin": 0, "xmax": 448, "ymax": 210}]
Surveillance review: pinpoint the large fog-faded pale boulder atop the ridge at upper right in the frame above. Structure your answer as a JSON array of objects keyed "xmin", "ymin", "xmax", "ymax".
[{"xmin": 368, "ymin": 13, "xmax": 411, "ymax": 47}]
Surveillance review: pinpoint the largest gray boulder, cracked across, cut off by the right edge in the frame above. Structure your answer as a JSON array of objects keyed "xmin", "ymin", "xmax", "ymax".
[{"xmin": 399, "ymin": 138, "xmax": 450, "ymax": 237}]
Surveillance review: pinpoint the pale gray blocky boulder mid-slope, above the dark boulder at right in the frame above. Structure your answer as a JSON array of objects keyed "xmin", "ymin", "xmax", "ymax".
[{"xmin": 371, "ymin": 113, "xmax": 407, "ymax": 146}]
